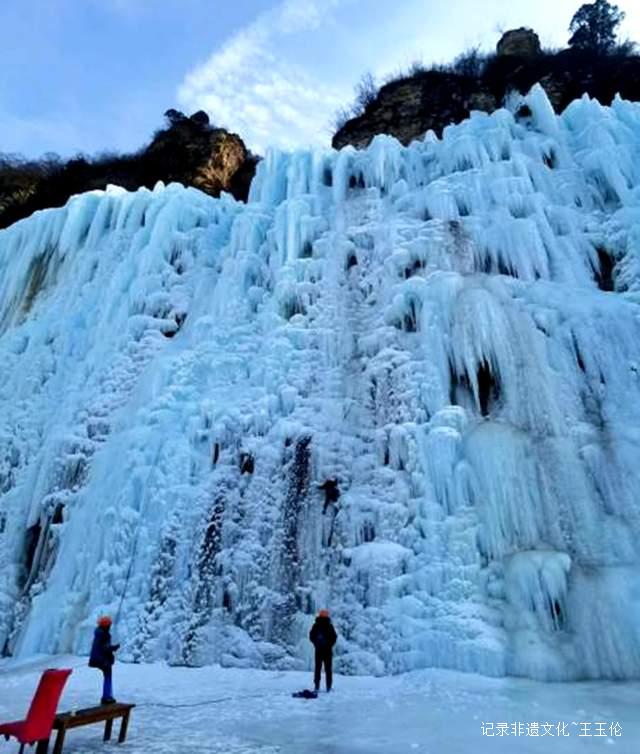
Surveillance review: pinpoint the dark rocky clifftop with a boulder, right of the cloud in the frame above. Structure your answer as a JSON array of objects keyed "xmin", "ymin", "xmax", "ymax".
[{"xmin": 332, "ymin": 39, "xmax": 640, "ymax": 149}]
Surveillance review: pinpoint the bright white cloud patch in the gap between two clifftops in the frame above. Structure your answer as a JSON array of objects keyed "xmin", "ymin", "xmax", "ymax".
[{"xmin": 178, "ymin": 0, "xmax": 350, "ymax": 152}]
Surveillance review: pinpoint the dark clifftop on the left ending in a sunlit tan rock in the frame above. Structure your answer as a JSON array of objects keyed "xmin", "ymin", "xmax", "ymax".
[{"xmin": 0, "ymin": 110, "xmax": 257, "ymax": 228}]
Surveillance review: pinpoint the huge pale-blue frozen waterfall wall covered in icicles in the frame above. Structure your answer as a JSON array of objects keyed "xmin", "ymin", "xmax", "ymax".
[{"xmin": 0, "ymin": 87, "xmax": 640, "ymax": 679}]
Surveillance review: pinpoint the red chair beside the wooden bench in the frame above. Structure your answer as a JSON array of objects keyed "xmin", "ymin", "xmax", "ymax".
[{"xmin": 0, "ymin": 670, "xmax": 71, "ymax": 754}]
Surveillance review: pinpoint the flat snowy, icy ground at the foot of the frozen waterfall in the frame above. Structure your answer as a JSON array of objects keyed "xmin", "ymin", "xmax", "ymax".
[{"xmin": 0, "ymin": 657, "xmax": 640, "ymax": 754}]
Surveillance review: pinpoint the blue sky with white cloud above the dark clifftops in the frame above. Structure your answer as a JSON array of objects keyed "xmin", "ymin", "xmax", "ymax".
[{"xmin": 0, "ymin": 0, "xmax": 640, "ymax": 157}]
